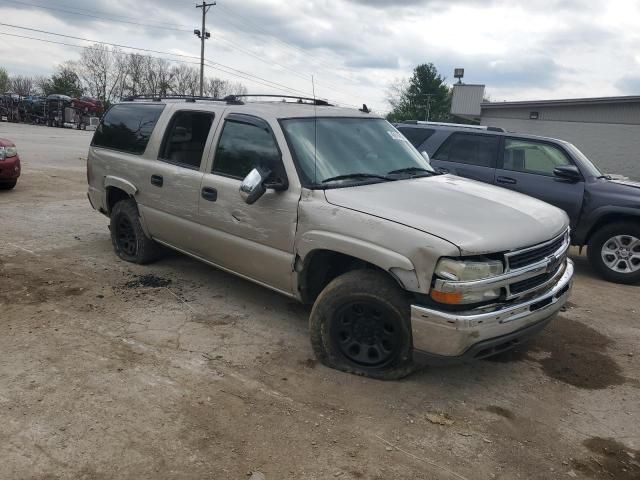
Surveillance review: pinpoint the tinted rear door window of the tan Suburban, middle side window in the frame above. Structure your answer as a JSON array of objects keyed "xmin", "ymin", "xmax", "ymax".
[{"xmin": 160, "ymin": 110, "xmax": 213, "ymax": 170}]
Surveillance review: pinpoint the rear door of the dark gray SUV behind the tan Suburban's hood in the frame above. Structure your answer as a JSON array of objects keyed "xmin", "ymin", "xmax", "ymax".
[{"xmin": 431, "ymin": 132, "xmax": 500, "ymax": 183}]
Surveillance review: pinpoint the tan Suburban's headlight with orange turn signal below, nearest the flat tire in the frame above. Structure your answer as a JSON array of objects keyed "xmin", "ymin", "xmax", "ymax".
[{"xmin": 431, "ymin": 258, "xmax": 504, "ymax": 305}]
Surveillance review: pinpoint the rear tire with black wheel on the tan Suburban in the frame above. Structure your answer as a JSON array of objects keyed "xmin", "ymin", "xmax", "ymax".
[{"xmin": 109, "ymin": 198, "xmax": 162, "ymax": 265}]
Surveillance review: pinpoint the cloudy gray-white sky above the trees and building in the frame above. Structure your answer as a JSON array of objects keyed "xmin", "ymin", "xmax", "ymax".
[{"xmin": 0, "ymin": 0, "xmax": 640, "ymax": 112}]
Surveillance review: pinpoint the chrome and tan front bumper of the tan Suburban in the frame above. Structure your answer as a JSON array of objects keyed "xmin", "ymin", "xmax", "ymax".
[{"xmin": 411, "ymin": 259, "xmax": 574, "ymax": 363}]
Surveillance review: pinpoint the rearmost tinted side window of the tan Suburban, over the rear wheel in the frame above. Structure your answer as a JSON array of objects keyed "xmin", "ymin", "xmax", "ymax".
[{"xmin": 91, "ymin": 103, "xmax": 164, "ymax": 155}]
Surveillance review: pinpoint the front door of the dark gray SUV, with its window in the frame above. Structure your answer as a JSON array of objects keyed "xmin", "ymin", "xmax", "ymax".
[{"xmin": 495, "ymin": 138, "xmax": 584, "ymax": 227}]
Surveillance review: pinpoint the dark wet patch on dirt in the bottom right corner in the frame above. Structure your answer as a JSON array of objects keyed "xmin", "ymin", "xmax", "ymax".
[{"xmin": 572, "ymin": 437, "xmax": 640, "ymax": 480}]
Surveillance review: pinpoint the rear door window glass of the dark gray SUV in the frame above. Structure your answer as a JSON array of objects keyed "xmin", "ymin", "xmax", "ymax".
[{"xmin": 433, "ymin": 133, "xmax": 498, "ymax": 167}]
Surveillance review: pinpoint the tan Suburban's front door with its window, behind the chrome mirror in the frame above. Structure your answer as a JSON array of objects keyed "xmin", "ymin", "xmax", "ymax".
[{"xmin": 198, "ymin": 113, "xmax": 300, "ymax": 294}]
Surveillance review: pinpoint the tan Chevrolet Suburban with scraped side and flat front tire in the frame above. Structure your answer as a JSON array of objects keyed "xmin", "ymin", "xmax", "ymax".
[{"xmin": 87, "ymin": 96, "xmax": 573, "ymax": 379}]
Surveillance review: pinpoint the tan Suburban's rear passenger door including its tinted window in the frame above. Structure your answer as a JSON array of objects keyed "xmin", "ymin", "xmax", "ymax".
[{"xmin": 136, "ymin": 110, "xmax": 214, "ymax": 253}]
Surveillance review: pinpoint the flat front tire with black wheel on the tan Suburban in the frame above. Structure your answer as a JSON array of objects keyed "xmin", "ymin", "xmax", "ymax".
[{"xmin": 309, "ymin": 270, "xmax": 414, "ymax": 380}]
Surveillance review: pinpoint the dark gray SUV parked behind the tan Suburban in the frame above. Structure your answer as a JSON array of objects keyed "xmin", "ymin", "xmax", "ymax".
[{"xmin": 396, "ymin": 121, "xmax": 640, "ymax": 283}]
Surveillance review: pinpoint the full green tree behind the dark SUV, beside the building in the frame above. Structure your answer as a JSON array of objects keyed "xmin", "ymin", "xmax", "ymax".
[{"xmin": 387, "ymin": 63, "xmax": 451, "ymax": 122}]
